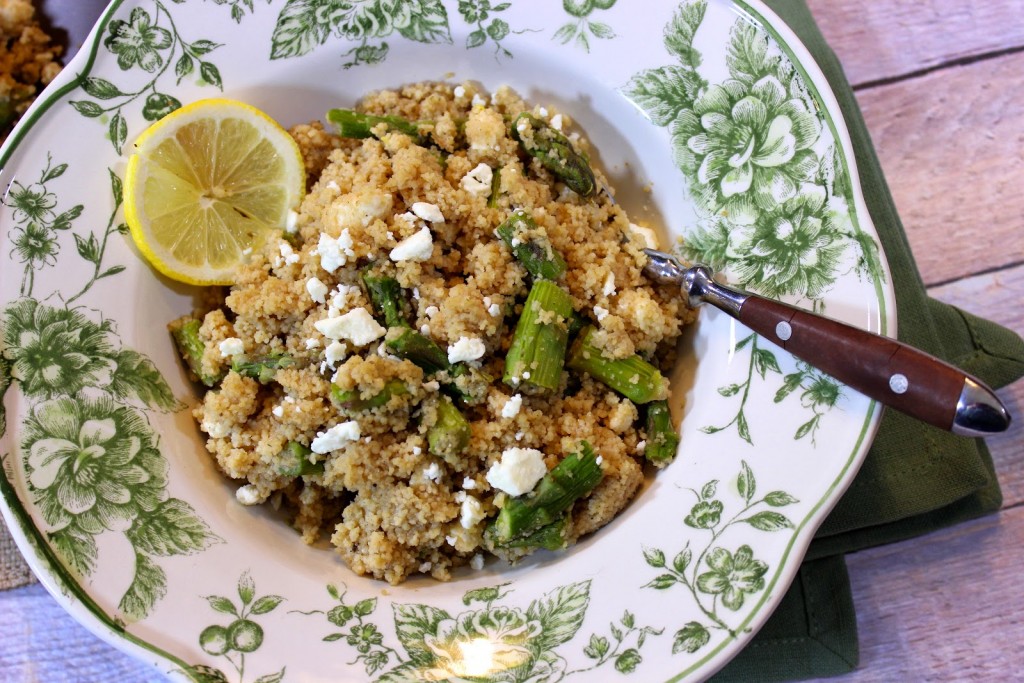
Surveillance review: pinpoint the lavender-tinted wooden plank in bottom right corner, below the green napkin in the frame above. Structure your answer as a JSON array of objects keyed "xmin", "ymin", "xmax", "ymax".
[{"xmin": 811, "ymin": 507, "xmax": 1024, "ymax": 683}]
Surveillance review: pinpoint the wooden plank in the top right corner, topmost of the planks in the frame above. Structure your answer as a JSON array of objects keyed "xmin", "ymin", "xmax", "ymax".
[{"xmin": 807, "ymin": 0, "xmax": 1024, "ymax": 85}]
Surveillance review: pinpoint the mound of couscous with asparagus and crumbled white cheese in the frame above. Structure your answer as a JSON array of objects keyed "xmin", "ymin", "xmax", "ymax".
[{"xmin": 155, "ymin": 83, "xmax": 692, "ymax": 584}]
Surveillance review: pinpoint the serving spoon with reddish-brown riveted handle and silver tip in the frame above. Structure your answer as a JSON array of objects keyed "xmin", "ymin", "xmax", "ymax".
[{"xmin": 643, "ymin": 249, "xmax": 1010, "ymax": 436}]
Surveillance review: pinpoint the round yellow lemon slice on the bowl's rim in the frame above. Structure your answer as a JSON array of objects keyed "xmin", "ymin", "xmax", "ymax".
[{"xmin": 124, "ymin": 99, "xmax": 305, "ymax": 285}]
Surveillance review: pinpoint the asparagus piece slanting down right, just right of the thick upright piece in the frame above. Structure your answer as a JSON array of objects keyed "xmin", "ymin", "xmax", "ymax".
[{"xmin": 565, "ymin": 326, "xmax": 669, "ymax": 403}]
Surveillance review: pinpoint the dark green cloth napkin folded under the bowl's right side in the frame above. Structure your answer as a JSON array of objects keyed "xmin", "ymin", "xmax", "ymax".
[{"xmin": 713, "ymin": 0, "xmax": 1024, "ymax": 682}]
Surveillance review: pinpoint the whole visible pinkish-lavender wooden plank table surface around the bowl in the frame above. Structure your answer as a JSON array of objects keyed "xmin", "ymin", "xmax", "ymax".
[{"xmin": 0, "ymin": 0, "xmax": 1024, "ymax": 683}]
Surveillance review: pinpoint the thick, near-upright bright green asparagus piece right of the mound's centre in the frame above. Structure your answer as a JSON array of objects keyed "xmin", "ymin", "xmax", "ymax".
[{"xmin": 502, "ymin": 280, "xmax": 572, "ymax": 392}]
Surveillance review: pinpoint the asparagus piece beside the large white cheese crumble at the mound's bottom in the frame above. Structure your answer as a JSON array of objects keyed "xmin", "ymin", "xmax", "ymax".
[{"xmin": 487, "ymin": 441, "xmax": 603, "ymax": 548}]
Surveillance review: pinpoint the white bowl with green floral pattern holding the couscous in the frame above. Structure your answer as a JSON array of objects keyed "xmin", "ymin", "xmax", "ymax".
[{"xmin": 0, "ymin": 0, "xmax": 895, "ymax": 683}]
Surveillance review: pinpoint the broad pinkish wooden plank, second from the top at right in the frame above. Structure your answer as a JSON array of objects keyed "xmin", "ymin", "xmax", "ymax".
[{"xmin": 858, "ymin": 52, "xmax": 1024, "ymax": 283}]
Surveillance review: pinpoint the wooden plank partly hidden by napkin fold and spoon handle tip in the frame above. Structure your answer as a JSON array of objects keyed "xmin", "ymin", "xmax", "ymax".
[{"xmin": 929, "ymin": 265, "xmax": 1024, "ymax": 507}]
